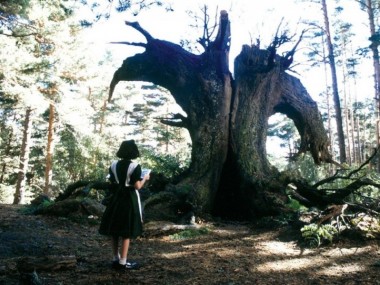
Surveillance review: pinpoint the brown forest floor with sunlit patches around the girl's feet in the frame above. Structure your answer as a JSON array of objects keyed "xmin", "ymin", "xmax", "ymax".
[{"xmin": 0, "ymin": 204, "xmax": 380, "ymax": 285}]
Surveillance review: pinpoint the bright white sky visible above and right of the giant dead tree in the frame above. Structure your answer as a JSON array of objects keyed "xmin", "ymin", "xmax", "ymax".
[{"xmin": 85, "ymin": 0, "xmax": 373, "ymax": 104}]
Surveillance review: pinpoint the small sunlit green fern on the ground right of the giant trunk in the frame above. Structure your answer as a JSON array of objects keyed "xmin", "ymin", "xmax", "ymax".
[{"xmin": 301, "ymin": 224, "xmax": 338, "ymax": 247}]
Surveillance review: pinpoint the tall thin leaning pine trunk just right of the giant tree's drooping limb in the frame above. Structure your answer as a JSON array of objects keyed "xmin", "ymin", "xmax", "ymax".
[{"xmin": 321, "ymin": 0, "xmax": 347, "ymax": 163}]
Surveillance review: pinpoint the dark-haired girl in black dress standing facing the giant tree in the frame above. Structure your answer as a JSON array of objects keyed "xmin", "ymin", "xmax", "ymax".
[{"xmin": 99, "ymin": 140, "xmax": 150, "ymax": 270}]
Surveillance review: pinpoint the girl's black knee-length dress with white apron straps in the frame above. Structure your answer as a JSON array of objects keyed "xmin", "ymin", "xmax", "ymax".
[{"xmin": 99, "ymin": 160, "xmax": 142, "ymax": 239}]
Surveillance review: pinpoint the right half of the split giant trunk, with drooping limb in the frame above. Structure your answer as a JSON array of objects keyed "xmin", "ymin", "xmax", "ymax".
[{"xmin": 218, "ymin": 46, "xmax": 331, "ymax": 216}]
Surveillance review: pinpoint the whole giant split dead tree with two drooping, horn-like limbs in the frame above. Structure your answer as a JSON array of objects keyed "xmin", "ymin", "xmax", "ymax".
[{"xmin": 109, "ymin": 11, "xmax": 331, "ymax": 218}]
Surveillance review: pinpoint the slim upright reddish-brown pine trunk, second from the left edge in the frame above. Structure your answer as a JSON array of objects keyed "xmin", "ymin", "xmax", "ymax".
[{"xmin": 44, "ymin": 102, "xmax": 55, "ymax": 195}]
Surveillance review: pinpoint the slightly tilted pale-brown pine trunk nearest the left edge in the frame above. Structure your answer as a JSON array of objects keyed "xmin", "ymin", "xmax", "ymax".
[{"xmin": 13, "ymin": 107, "xmax": 32, "ymax": 204}]
